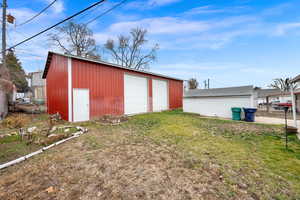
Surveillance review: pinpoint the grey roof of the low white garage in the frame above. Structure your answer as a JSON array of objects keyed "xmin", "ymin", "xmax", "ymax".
[{"xmin": 184, "ymin": 85, "xmax": 254, "ymax": 98}]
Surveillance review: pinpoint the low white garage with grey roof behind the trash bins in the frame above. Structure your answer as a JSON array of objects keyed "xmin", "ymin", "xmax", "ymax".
[{"xmin": 183, "ymin": 86, "xmax": 257, "ymax": 118}]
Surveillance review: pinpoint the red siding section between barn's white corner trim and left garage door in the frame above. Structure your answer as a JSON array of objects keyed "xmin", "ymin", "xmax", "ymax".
[{"xmin": 72, "ymin": 59, "xmax": 124, "ymax": 118}]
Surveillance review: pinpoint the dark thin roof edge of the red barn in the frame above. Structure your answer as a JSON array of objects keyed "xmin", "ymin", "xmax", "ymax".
[{"xmin": 43, "ymin": 51, "xmax": 183, "ymax": 81}]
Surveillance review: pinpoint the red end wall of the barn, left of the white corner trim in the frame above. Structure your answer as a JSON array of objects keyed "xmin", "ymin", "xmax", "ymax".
[{"xmin": 46, "ymin": 55, "xmax": 68, "ymax": 120}]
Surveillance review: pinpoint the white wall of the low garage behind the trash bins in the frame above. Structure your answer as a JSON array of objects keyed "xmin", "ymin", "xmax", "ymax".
[{"xmin": 183, "ymin": 96, "xmax": 252, "ymax": 118}]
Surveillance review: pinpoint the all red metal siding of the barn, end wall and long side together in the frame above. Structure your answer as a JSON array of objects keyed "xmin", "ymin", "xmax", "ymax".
[{"xmin": 46, "ymin": 54, "xmax": 183, "ymax": 120}]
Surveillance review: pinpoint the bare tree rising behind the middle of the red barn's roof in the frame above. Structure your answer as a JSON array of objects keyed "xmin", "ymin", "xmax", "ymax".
[{"xmin": 105, "ymin": 28, "xmax": 159, "ymax": 70}]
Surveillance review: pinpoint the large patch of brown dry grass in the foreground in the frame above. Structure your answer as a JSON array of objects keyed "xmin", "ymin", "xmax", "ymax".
[{"xmin": 0, "ymin": 128, "xmax": 253, "ymax": 200}]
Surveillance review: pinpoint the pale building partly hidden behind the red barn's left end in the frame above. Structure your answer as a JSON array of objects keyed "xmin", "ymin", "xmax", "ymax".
[{"xmin": 28, "ymin": 71, "xmax": 46, "ymax": 101}]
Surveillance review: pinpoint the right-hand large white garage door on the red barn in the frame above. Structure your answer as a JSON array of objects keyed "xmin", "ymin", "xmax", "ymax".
[{"xmin": 152, "ymin": 79, "xmax": 169, "ymax": 111}]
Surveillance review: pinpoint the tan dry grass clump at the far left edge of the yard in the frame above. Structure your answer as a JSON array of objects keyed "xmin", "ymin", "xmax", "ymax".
[{"xmin": 1, "ymin": 114, "xmax": 30, "ymax": 129}]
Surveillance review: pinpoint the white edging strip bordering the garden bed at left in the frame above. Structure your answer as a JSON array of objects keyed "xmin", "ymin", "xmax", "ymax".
[{"xmin": 0, "ymin": 130, "xmax": 86, "ymax": 170}]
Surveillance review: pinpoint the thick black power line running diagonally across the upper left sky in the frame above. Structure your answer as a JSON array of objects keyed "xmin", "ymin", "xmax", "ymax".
[{"xmin": 4, "ymin": 0, "xmax": 106, "ymax": 51}]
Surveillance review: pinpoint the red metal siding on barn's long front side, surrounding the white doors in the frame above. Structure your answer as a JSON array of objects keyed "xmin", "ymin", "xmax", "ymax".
[{"xmin": 72, "ymin": 59, "xmax": 183, "ymax": 118}]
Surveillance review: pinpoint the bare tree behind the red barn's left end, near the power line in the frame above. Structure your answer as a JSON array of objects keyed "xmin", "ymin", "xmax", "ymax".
[{"xmin": 48, "ymin": 22, "xmax": 100, "ymax": 59}]
